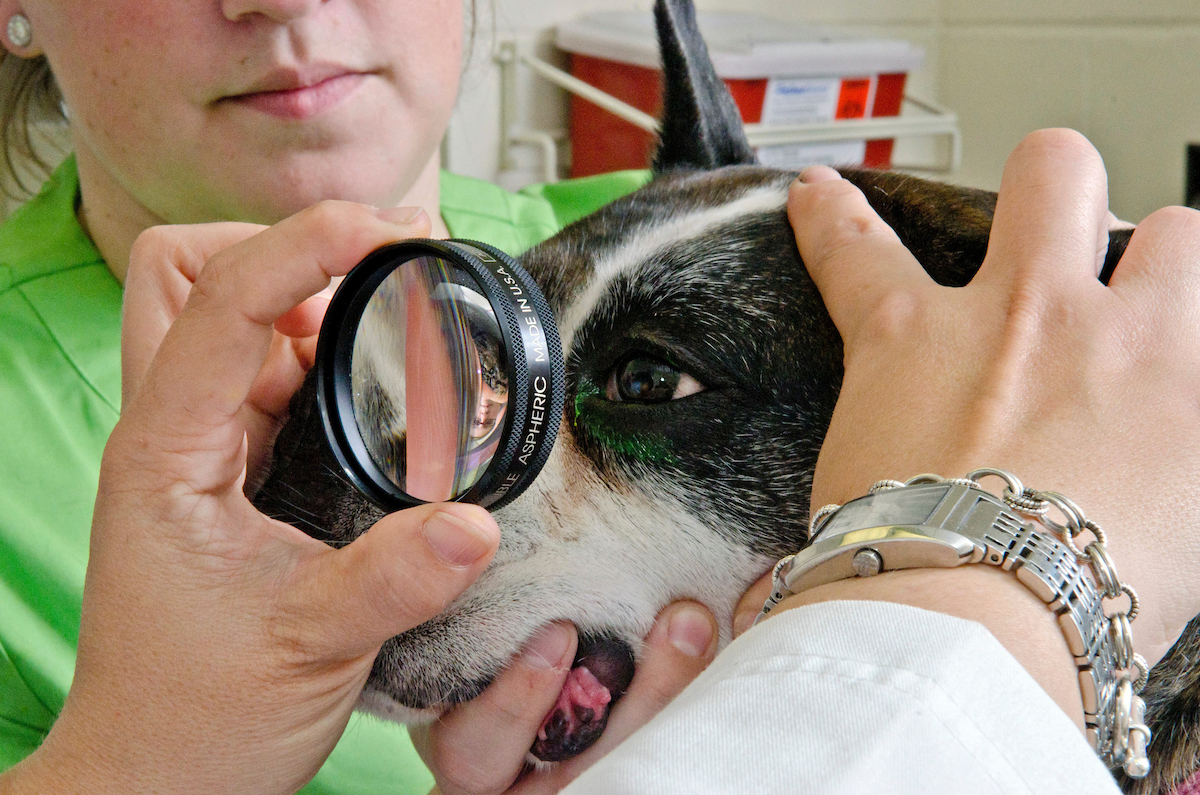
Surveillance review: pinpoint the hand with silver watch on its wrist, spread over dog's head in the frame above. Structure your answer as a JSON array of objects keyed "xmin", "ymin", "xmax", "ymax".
[{"xmin": 739, "ymin": 130, "xmax": 1200, "ymax": 712}]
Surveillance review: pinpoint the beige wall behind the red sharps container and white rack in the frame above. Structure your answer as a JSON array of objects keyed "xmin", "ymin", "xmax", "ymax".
[{"xmin": 451, "ymin": 0, "xmax": 1200, "ymax": 221}]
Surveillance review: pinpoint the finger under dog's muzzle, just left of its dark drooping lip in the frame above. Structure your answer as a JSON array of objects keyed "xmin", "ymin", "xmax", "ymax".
[{"xmin": 412, "ymin": 623, "xmax": 577, "ymax": 795}]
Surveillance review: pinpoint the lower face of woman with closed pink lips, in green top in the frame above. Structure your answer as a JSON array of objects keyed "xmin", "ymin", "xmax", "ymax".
[{"xmin": 22, "ymin": 0, "xmax": 462, "ymax": 223}]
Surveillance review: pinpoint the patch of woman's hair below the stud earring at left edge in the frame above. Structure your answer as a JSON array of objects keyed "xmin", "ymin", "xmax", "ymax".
[{"xmin": 0, "ymin": 49, "xmax": 66, "ymax": 199}]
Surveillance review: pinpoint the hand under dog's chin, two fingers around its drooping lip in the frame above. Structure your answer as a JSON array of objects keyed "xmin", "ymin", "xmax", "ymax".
[{"xmin": 410, "ymin": 602, "xmax": 716, "ymax": 795}]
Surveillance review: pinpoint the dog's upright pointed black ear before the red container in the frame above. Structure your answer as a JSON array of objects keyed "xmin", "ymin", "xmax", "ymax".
[{"xmin": 654, "ymin": 0, "xmax": 755, "ymax": 174}]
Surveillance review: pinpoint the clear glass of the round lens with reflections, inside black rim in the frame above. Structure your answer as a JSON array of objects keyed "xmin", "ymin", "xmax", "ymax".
[{"xmin": 350, "ymin": 256, "xmax": 509, "ymax": 502}]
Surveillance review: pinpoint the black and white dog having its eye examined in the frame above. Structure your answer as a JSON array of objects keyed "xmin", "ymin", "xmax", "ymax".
[{"xmin": 256, "ymin": 0, "xmax": 1200, "ymax": 793}]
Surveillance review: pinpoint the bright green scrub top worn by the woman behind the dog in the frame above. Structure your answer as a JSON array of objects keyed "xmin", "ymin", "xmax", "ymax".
[{"xmin": 0, "ymin": 157, "xmax": 647, "ymax": 795}]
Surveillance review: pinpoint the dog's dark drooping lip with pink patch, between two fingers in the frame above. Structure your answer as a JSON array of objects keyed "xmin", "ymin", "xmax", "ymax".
[{"xmin": 530, "ymin": 635, "xmax": 634, "ymax": 761}]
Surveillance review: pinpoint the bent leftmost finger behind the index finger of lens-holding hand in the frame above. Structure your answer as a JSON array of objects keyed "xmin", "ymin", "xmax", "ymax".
[{"xmin": 121, "ymin": 222, "xmax": 266, "ymax": 406}]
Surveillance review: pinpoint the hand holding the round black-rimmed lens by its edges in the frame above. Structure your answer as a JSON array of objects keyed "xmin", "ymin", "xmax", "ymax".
[{"xmin": 7, "ymin": 203, "xmax": 499, "ymax": 793}]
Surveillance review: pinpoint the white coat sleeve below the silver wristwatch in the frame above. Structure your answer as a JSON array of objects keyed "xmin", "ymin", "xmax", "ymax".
[{"xmin": 565, "ymin": 602, "xmax": 1120, "ymax": 795}]
